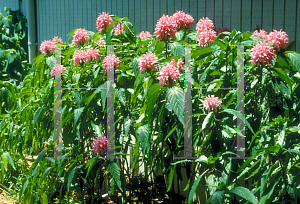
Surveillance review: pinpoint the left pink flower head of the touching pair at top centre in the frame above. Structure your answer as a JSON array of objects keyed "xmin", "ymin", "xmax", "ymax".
[{"xmin": 155, "ymin": 15, "xmax": 177, "ymax": 41}]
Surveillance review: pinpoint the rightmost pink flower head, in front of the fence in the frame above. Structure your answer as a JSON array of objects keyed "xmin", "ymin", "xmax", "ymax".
[{"xmin": 268, "ymin": 29, "xmax": 289, "ymax": 51}]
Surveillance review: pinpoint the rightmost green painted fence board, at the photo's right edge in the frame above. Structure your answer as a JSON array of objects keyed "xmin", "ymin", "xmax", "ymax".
[{"xmin": 284, "ymin": 0, "xmax": 299, "ymax": 49}]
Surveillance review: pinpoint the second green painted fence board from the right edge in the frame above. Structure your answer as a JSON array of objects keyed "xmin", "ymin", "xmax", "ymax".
[{"xmin": 273, "ymin": 0, "xmax": 284, "ymax": 30}]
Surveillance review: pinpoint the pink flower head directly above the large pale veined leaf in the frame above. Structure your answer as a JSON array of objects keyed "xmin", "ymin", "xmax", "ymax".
[{"xmin": 157, "ymin": 62, "xmax": 180, "ymax": 87}]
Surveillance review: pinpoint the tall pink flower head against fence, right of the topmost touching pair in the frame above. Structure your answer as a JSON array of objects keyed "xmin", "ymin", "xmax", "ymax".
[{"xmin": 196, "ymin": 17, "xmax": 217, "ymax": 46}]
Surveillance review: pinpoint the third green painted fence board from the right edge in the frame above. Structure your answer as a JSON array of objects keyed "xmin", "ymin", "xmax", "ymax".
[{"xmin": 262, "ymin": 0, "xmax": 273, "ymax": 32}]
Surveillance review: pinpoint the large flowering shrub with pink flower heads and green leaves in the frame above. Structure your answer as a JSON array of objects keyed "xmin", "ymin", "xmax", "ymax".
[{"xmin": 4, "ymin": 8, "xmax": 300, "ymax": 204}]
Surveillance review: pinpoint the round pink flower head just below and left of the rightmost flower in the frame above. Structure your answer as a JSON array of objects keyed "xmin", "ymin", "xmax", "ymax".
[{"xmin": 250, "ymin": 42, "xmax": 275, "ymax": 65}]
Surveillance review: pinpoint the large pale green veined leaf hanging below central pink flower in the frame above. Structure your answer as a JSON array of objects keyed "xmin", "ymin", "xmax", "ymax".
[{"xmin": 167, "ymin": 86, "xmax": 184, "ymax": 125}]
